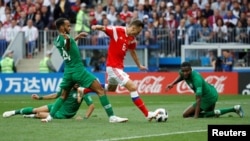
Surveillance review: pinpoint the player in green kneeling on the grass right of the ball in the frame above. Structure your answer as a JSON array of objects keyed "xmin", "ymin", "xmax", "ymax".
[{"xmin": 166, "ymin": 62, "xmax": 244, "ymax": 118}]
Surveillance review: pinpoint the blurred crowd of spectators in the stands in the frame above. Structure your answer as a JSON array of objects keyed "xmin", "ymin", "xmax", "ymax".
[{"xmin": 0, "ymin": 0, "xmax": 250, "ymax": 70}]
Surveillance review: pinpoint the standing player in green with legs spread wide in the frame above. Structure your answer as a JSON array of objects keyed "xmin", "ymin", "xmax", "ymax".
[{"xmin": 41, "ymin": 18, "xmax": 128, "ymax": 123}]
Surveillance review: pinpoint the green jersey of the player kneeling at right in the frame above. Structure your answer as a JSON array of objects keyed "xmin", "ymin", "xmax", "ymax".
[{"xmin": 179, "ymin": 70, "xmax": 218, "ymax": 101}]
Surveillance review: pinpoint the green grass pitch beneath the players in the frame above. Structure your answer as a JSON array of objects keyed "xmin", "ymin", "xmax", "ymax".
[{"xmin": 0, "ymin": 95, "xmax": 250, "ymax": 141}]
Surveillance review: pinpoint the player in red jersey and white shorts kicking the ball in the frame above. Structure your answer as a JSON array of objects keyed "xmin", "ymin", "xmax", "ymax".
[{"xmin": 91, "ymin": 20, "xmax": 158, "ymax": 121}]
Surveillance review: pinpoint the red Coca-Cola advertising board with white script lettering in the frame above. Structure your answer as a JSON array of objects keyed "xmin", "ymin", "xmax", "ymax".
[{"xmin": 115, "ymin": 72, "xmax": 238, "ymax": 95}]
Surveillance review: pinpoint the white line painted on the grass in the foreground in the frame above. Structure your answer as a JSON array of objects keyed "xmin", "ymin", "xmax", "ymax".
[{"xmin": 97, "ymin": 130, "xmax": 207, "ymax": 141}]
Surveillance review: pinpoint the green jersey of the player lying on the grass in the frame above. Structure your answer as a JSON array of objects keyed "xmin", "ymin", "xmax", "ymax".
[{"xmin": 57, "ymin": 90, "xmax": 93, "ymax": 117}]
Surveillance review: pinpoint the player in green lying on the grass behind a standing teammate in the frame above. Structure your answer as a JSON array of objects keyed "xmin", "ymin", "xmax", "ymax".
[{"xmin": 3, "ymin": 84, "xmax": 94, "ymax": 119}]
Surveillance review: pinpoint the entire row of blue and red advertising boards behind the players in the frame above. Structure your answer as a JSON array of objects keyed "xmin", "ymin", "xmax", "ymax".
[{"xmin": 0, "ymin": 72, "xmax": 238, "ymax": 95}]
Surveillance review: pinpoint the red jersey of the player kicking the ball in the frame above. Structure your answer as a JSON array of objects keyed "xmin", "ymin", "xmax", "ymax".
[{"xmin": 105, "ymin": 26, "xmax": 136, "ymax": 69}]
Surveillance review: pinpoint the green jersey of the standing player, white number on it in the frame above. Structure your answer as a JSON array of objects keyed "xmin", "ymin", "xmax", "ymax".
[{"xmin": 54, "ymin": 35, "xmax": 84, "ymax": 73}]
